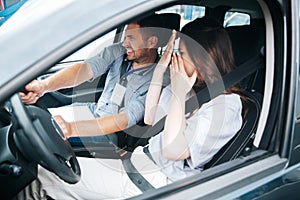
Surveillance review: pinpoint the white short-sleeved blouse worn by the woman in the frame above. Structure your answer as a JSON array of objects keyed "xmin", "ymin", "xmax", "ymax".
[{"xmin": 149, "ymin": 87, "xmax": 242, "ymax": 181}]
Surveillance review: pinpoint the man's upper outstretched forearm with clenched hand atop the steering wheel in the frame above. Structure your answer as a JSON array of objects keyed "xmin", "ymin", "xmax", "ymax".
[{"xmin": 20, "ymin": 62, "xmax": 93, "ymax": 104}]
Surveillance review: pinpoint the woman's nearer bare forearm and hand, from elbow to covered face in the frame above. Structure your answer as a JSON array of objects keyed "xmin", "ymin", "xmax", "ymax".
[{"xmin": 163, "ymin": 54, "xmax": 197, "ymax": 160}]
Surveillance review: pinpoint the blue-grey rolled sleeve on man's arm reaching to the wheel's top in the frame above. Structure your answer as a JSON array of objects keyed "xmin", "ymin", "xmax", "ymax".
[{"xmin": 85, "ymin": 43, "xmax": 125, "ymax": 81}]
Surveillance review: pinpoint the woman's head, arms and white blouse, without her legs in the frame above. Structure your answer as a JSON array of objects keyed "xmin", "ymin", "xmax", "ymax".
[{"xmin": 144, "ymin": 18, "xmax": 245, "ymax": 181}]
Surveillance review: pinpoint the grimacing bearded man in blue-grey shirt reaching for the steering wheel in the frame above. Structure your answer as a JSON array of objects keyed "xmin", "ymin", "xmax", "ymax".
[{"xmin": 20, "ymin": 14, "xmax": 169, "ymax": 148}]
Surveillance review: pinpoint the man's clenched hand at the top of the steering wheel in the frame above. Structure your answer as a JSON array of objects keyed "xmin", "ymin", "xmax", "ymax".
[{"xmin": 19, "ymin": 80, "xmax": 46, "ymax": 104}]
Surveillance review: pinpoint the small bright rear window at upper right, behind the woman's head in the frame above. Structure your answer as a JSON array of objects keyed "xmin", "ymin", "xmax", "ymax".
[{"xmin": 223, "ymin": 11, "xmax": 250, "ymax": 27}]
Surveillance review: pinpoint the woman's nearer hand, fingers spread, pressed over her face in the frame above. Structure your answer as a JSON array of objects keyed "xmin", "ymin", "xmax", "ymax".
[{"xmin": 170, "ymin": 53, "xmax": 197, "ymax": 95}]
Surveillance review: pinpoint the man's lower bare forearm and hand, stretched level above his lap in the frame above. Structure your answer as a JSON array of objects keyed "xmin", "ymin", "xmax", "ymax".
[{"xmin": 54, "ymin": 113, "xmax": 128, "ymax": 138}]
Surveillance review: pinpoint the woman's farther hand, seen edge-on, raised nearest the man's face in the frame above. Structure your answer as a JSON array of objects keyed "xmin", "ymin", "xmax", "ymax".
[{"xmin": 156, "ymin": 30, "xmax": 176, "ymax": 73}]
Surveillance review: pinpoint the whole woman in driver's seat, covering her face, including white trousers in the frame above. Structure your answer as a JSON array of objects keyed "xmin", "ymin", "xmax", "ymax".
[{"xmin": 19, "ymin": 18, "xmax": 242, "ymax": 199}]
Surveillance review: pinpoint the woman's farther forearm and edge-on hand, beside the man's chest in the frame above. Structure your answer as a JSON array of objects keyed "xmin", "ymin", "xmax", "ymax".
[{"xmin": 144, "ymin": 30, "xmax": 176, "ymax": 125}]
